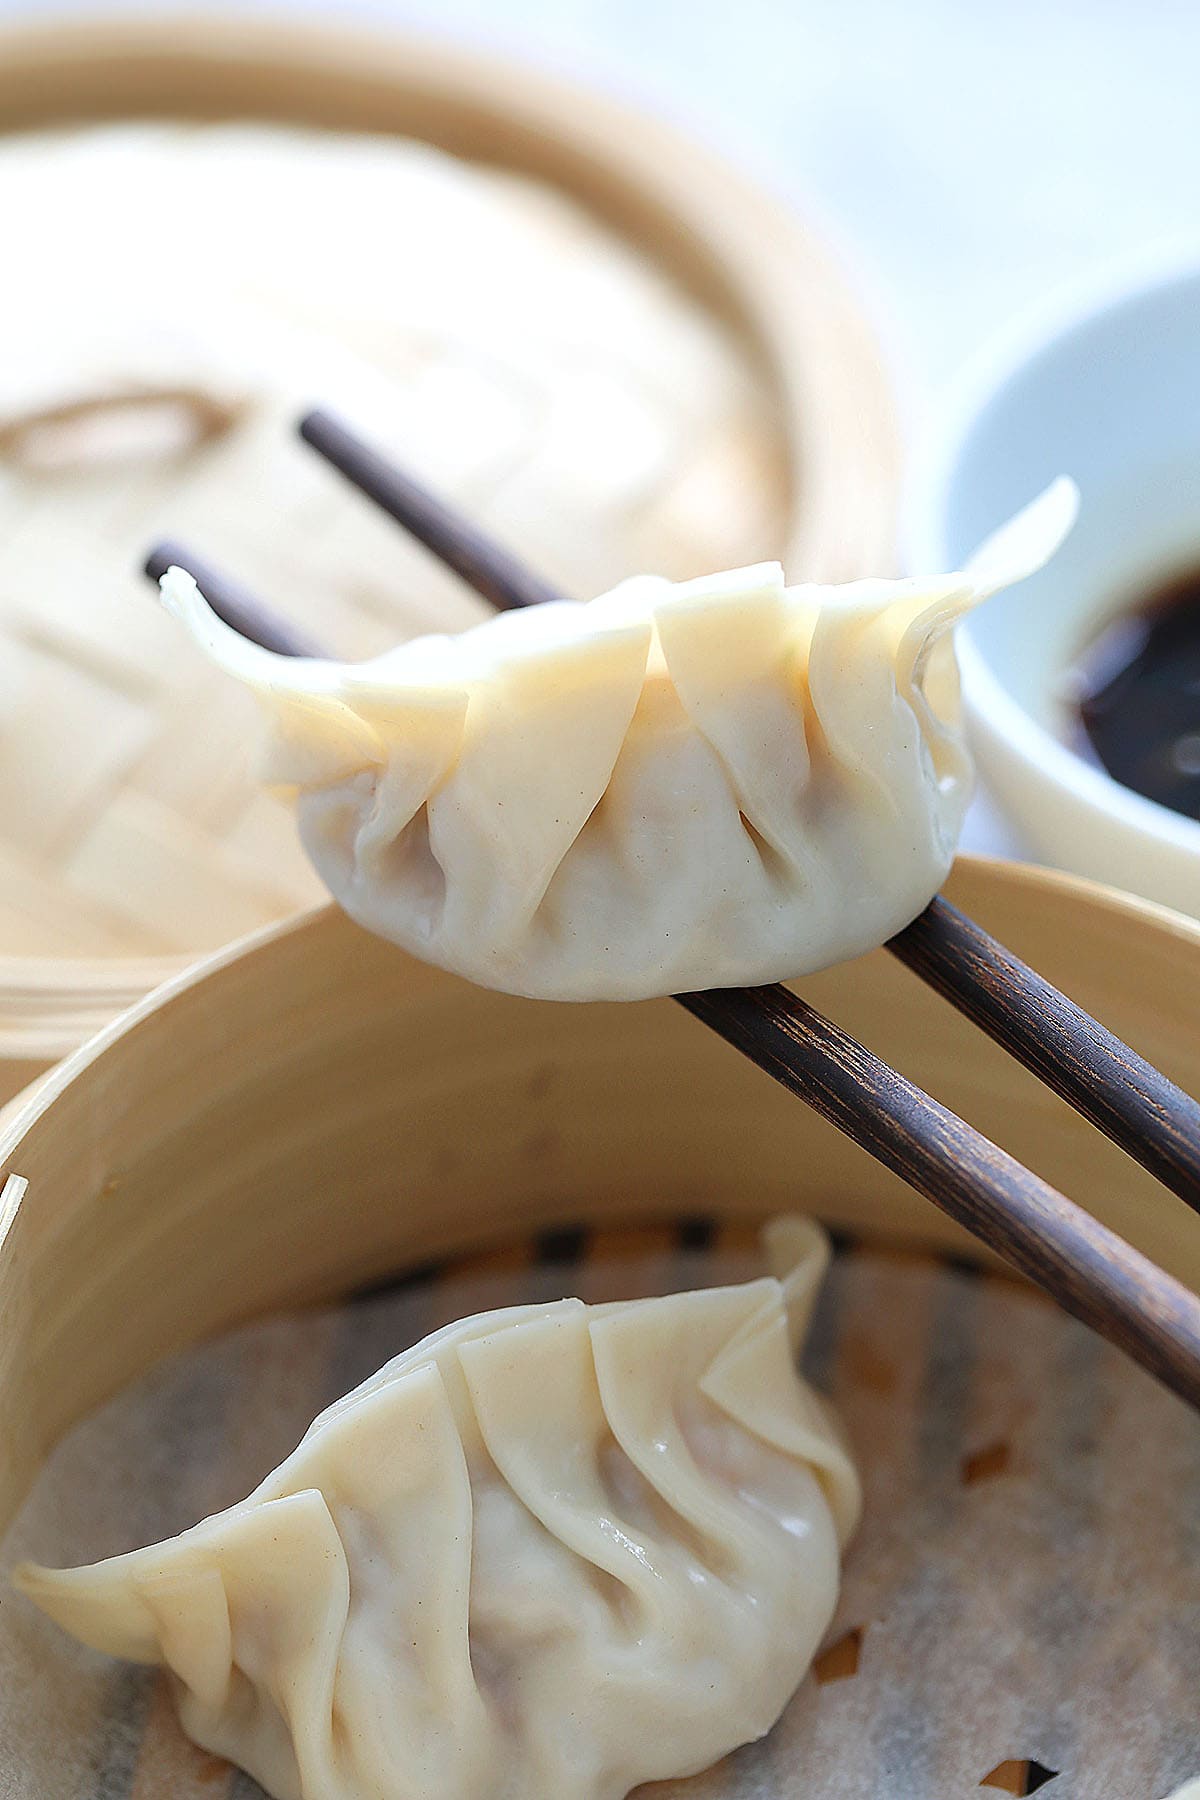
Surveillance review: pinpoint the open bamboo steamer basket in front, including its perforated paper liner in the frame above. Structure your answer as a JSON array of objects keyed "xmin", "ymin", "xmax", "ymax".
[{"xmin": 0, "ymin": 859, "xmax": 1200, "ymax": 1800}]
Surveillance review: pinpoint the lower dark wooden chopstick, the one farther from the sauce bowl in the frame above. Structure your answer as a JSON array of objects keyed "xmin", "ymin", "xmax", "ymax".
[{"xmin": 148, "ymin": 457, "xmax": 1200, "ymax": 1408}]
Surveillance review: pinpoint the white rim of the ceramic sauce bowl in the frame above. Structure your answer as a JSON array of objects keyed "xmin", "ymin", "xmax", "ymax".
[{"xmin": 901, "ymin": 236, "xmax": 1200, "ymax": 866}]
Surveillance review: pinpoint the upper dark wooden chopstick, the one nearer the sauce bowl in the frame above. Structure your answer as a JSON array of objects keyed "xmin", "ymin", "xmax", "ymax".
[{"xmin": 295, "ymin": 410, "xmax": 1200, "ymax": 1211}]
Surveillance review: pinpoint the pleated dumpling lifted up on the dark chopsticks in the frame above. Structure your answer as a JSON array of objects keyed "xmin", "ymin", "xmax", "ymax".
[{"xmin": 162, "ymin": 481, "xmax": 1078, "ymax": 1001}]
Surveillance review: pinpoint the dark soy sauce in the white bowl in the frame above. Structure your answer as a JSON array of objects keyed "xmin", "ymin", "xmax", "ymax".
[{"xmin": 1076, "ymin": 569, "xmax": 1200, "ymax": 819}]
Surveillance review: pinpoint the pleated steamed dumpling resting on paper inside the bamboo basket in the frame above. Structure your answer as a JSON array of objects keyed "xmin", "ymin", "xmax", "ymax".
[{"xmin": 16, "ymin": 1219, "xmax": 858, "ymax": 1800}]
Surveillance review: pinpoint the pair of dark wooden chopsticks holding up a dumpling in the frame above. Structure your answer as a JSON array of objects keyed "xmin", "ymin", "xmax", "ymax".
[{"xmin": 146, "ymin": 412, "xmax": 1200, "ymax": 1408}]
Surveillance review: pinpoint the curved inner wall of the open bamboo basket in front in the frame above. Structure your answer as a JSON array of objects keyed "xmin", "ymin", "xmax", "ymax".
[{"xmin": 0, "ymin": 859, "xmax": 1200, "ymax": 1526}]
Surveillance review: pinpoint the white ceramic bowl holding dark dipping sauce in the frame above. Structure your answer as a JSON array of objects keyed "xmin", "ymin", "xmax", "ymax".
[{"xmin": 907, "ymin": 248, "xmax": 1200, "ymax": 914}]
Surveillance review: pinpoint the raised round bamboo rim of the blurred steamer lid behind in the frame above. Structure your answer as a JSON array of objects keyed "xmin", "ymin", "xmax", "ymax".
[{"xmin": 0, "ymin": 5, "xmax": 900, "ymax": 1067}]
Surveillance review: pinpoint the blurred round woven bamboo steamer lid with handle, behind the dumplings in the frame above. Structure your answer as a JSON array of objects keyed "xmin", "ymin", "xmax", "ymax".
[{"xmin": 0, "ymin": 20, "xmax": 894, "ymax": 1091}]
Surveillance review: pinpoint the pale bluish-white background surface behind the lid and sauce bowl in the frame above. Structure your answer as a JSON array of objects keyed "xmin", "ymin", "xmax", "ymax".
[{"xmin": 16, "ymin": 0, "xmax": 1200, "ymax": 850}]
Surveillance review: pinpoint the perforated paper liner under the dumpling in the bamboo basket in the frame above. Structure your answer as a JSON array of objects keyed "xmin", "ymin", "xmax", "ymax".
[{"xmin": 0, "ymin": 1224, "xmax": 1200, "ymax": 1800}]
